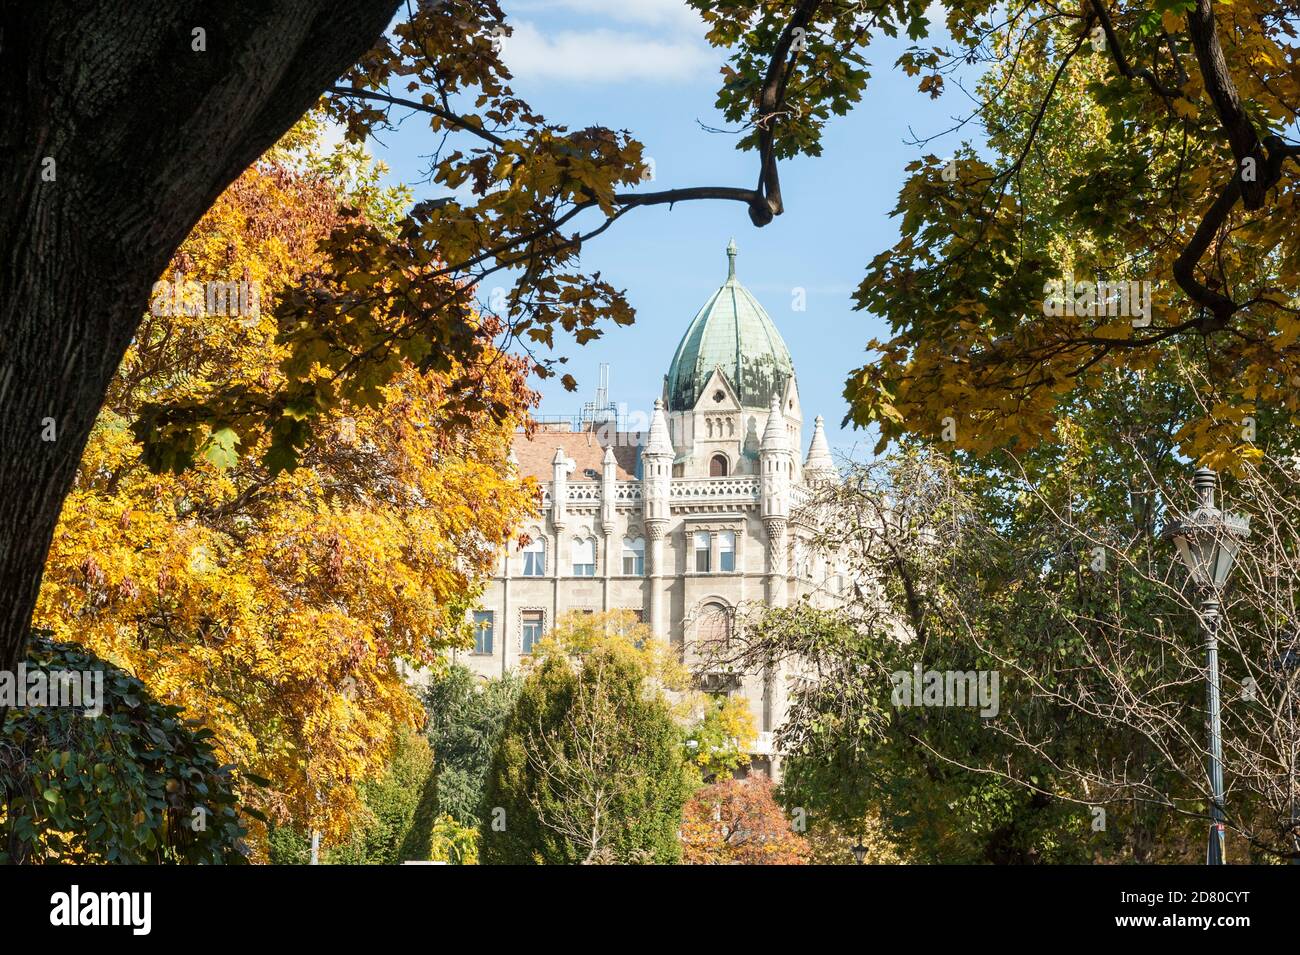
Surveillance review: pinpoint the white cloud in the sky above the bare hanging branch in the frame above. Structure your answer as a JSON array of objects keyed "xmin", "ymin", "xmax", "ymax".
[{"xmin": 501, "ymin": 21, "xmax": 718, "ymax": 83}]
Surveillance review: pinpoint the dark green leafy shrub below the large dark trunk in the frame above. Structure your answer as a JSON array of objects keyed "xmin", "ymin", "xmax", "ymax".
[{"xmin": 0, "ymin": 631, "xmax": 248, "ymax": 864}]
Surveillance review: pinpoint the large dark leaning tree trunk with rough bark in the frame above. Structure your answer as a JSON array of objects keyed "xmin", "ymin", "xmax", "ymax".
[{"xmin": 0, "ymin": 0, "xmax": 399, "ymax": 686}]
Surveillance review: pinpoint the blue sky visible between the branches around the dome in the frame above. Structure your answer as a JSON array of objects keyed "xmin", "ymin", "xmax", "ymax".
[{"xmin": 361, "ymin": 0, "xmax": 970, "ymax": 455}]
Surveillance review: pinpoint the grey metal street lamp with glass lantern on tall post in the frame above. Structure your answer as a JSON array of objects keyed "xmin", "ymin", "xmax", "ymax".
[{"xmin": 1165, "ymin": 468, "xmax": 1251, "ymax": 865}]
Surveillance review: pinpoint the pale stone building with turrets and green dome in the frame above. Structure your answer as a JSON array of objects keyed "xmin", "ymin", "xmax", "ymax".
[{"xmin": 460, "ymin": 242, "xmax": 836, "ymax": 770}]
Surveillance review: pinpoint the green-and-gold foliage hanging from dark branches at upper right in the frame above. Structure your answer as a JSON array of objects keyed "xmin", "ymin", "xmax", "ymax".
[{"xmin": 845, "ymin": 9, "xmax": 1300, "ymax": 472}]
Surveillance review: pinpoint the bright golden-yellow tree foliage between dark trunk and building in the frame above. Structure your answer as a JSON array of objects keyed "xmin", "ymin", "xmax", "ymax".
[{"xmin": 36, "ymin": 125, "xmax": 536, "ymax": 851}]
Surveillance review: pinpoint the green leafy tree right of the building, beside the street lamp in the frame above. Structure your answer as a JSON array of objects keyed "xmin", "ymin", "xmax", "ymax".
[{"xmin": 701, "ymin": 450, "xmax": 1191, "ymax": 863}]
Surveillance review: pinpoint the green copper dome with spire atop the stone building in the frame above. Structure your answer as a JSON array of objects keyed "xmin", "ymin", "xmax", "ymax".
[{"xmin": 667, "ymin": 239, "xmax": 794, "ymax": 411}]
